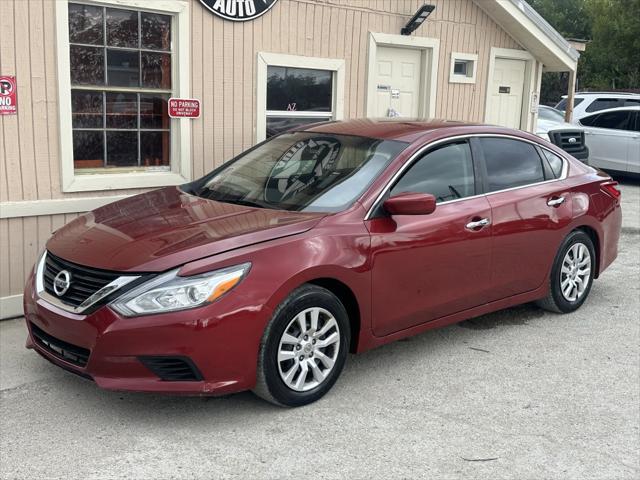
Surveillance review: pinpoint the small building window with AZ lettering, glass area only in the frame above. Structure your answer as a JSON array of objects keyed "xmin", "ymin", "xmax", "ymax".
[{"xmin": 267, "ymin": 65, "xmax": 334, "ymax": 138}]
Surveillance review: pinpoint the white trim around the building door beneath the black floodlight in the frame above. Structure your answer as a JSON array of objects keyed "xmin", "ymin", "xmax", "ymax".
[{"xmin": 365, "ymin": 32, "xmax": 440, "ymax": 118}]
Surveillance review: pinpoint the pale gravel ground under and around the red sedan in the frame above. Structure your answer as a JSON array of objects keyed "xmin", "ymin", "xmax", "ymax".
[{"xmin": 0, "ymin": 179, "xmax": 640, "ymax": 480}]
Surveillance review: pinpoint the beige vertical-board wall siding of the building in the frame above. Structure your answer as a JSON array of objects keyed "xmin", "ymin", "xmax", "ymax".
[{"xmin": 0, "ymin": 0, "xmax": 520, "ymax": 297}]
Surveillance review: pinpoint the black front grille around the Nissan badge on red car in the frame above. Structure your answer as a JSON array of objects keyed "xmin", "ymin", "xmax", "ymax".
[{"xmin": 43, "ymin": 252, "xmax": 120, "ymax": 307}]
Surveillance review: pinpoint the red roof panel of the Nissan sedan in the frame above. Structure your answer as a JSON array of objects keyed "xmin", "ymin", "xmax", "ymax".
[{"xmin": 299, "ymin": 117, "xmax": 496, "ymax": 143}]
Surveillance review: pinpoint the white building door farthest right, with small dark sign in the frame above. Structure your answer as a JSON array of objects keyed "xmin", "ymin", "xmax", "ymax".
[{"xmin": 487, "ymin": 58, "xmax": 527, "ymax": 128}]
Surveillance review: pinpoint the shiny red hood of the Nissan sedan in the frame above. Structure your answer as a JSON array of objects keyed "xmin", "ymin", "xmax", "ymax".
[{"xmin": 47, "ymin": 187, "xmax": 326, "ymax": 272}]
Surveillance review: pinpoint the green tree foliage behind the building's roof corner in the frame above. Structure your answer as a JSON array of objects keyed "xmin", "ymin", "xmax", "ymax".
[{"xmin": 529, "ymin": 0, "xmax": 640, "ymax": 103}]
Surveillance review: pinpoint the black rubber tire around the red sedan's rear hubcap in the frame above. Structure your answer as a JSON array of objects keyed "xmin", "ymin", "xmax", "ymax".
[{"xmin": 536, "ymin": 230, "xmax": 596, "ymax": 313}]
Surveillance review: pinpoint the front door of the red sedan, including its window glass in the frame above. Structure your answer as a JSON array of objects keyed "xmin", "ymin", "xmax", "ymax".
[{"xmin": 367, "ymin": 141, "xmax": 491, "ymax": 336}]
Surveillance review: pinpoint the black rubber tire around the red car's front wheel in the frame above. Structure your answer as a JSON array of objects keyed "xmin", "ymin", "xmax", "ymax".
[{"xmin": 253, "ymin": 284, "xmax": 351, "ymax": 407}]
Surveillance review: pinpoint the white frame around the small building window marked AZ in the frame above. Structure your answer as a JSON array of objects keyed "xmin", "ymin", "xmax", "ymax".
[{"xmin": 256, "ymin": 52, "xmax": 345, "ymax": 142}]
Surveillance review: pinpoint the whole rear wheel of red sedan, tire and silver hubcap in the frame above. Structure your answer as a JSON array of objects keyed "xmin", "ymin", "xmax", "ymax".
[{"xmin": 537, "ymin": 230, "xmax": 596, "ymax": 313}]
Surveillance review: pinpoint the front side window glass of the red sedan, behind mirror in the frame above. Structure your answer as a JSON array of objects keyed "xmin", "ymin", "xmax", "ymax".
[{"xmin": 391, "ymin": 142, "xmax": 475, "ymax": 202}]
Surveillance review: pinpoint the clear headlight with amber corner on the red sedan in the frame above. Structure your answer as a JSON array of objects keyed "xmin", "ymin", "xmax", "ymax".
[{"xmin": 111, "ymin": 263, "xmax": 251, "ymax": 317}]
